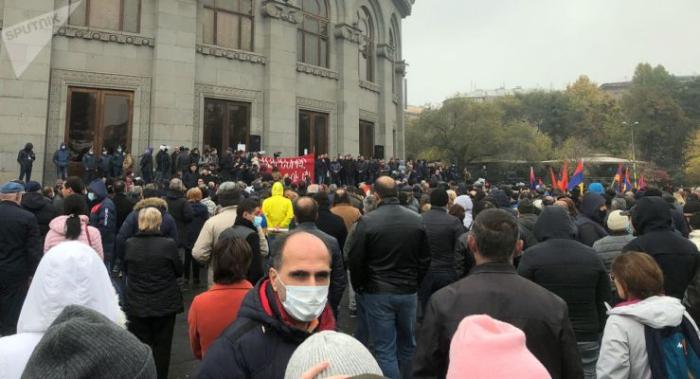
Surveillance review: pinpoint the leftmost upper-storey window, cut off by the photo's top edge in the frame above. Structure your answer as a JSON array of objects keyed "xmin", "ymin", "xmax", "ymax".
[{"xmin": 68, "ymin": 0, "xmax": 141, "ymax": 33}]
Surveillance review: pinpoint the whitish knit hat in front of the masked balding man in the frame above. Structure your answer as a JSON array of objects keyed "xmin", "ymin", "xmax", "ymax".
[{"xmin": 284, "ymin": 331, "xmax": 382, "ymax": 379}]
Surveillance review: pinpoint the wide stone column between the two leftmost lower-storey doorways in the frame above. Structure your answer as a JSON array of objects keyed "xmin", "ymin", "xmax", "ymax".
[{"xmin": 149, "ymin": 0, "xmax": 198, "ymax": 154}]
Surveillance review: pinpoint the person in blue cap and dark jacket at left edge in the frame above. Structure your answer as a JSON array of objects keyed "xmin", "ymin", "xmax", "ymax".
[{"xmin": 0, "ymin": 182, "xmax": 43, "ymax": 336}]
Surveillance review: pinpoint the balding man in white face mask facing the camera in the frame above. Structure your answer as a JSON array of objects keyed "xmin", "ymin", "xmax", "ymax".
[{"xmin": 198, "ymin": 231, "xmax": 335, "ymax": 379}]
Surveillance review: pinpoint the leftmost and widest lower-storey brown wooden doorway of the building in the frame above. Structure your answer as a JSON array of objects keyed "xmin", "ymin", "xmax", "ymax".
[{"xmin": 65, "ymin": 87, "xmax": 134, "ymax": 175}]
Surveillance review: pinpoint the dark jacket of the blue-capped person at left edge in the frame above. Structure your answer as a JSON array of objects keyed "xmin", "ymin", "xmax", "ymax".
[{"xmin": 0, "ymin": 201, "xmax": 44, "ymax": 288}]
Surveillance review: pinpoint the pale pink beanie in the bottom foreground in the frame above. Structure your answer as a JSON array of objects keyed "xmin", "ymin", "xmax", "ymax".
[{"xmin": 447, "ymin": 315, "xmax": 551, "ymax": 379}]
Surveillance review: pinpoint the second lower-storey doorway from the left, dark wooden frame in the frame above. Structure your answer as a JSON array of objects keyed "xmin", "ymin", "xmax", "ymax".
[{"xmin": 204, "ymin": 99, "xmax": 250, "ymax": 153}]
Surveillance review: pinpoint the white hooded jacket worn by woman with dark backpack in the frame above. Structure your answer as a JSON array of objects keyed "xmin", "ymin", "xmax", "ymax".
[{"xmin": 596, "ymin": 296, "xmax": 697, "ymax": 379}]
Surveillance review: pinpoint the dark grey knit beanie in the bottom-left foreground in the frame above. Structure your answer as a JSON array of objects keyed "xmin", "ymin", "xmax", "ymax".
[{"xmin": 22, "ymin": 305, "xmax": 156, "ymax": 379}]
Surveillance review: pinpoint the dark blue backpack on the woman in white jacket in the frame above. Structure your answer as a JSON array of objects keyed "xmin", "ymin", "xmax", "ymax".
[{"xmin": 644, "ymin": 316, "xmax": 700, "ymax": 379}]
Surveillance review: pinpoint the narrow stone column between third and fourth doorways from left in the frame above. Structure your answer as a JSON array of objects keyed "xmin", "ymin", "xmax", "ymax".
[{"xmin": 335, "ymin": 24, "xmax": 360, "ymax": 156}]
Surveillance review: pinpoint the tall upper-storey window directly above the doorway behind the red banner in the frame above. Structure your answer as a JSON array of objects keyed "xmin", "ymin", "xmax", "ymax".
[{"xmin": 297, "ymin": 0, "xmax": 328, "ymax": 67}]
